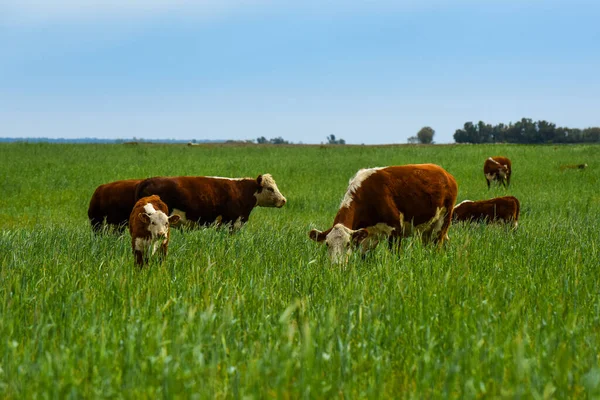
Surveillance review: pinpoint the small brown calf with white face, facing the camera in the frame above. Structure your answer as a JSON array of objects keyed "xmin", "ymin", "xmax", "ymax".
[{"xmin": 129, "ymin": 196, "xmax": 179, "ymax": 267}]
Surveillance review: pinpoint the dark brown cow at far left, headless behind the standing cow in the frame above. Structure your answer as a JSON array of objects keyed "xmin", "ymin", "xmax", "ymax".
[{"xmin": 88, "ymin": 179, "xmax": 142, "ymax": 231}]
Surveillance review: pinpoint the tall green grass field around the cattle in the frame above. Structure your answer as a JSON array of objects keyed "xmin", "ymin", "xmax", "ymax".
[{"xmin": 0, "ymin": 143, "xmax": 600, "ymax": 399}]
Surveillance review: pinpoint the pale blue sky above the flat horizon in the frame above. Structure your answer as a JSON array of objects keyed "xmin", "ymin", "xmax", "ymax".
[{"xmin": 0, "ymin": 0, "xmax": 600, "ymax": 144}]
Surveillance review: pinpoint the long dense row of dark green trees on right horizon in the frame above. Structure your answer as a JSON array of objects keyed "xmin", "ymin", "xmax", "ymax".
[{"xmin": 454, "ymin": 118, "xmax": 600, "ymax": 144}]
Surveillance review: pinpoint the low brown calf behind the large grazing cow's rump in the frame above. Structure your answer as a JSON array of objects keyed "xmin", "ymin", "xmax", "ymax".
[{"xmin": 453, "ymin": 196, "xmax": 521, "ymax": 228}]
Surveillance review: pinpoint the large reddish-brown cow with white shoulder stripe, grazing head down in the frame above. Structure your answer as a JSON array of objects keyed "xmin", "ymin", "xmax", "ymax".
[{"xmin": 309, "ymin": 164, "xmax": 458, "ymax": 263}]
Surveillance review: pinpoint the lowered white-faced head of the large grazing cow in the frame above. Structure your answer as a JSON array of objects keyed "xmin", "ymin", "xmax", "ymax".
[{"xmin": 308, "ymin": 224, "xmax": 369, "ymax": 264}]
